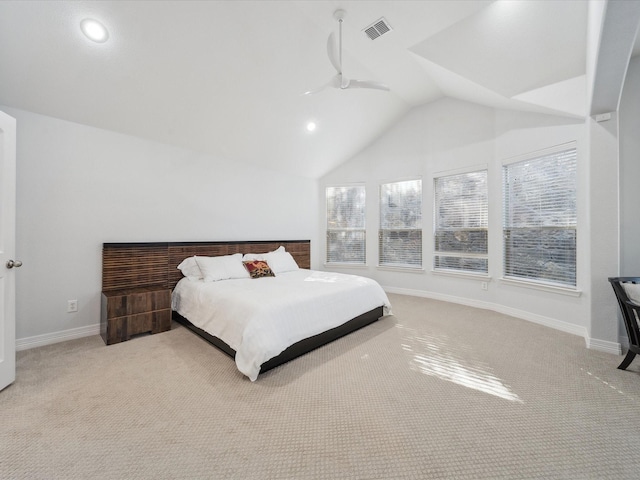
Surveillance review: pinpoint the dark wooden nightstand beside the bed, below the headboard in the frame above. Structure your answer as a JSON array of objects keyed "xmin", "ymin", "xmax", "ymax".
[{"xmin": 100, "ymin": 285, "xmax": 171, "ymax": 345}]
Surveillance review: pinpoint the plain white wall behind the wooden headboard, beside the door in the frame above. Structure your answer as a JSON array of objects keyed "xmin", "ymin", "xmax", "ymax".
[{"xmin": 0, "ymin": 106, "xmax": 318, "ymax": 348}]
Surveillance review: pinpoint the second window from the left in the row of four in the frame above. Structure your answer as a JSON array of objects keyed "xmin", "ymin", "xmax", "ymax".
[{"xmin": 378, "ymin": 180, "xmax": 422, "ymax": 268}]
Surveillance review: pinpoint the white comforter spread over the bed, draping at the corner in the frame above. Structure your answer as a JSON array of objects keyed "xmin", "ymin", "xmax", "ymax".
[{"xmin": 172, "ymin": 269, "xmax": 391, "ymax": 381}]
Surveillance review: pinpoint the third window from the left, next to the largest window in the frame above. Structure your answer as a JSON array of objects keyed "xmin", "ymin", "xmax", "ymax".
[{"xmin": 433, "ymin": 170, "xmax": 489, "ymax": 273}]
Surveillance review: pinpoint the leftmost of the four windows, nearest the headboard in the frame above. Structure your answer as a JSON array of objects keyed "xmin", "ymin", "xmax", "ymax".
[{"xmin": 326, "ymin": 185, "xmax": 366, "ymax": 265}]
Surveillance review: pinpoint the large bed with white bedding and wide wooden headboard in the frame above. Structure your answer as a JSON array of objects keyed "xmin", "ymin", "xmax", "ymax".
[{"xmin": 103, "ymin": 240, "xmax": 390, "ymax": 381}]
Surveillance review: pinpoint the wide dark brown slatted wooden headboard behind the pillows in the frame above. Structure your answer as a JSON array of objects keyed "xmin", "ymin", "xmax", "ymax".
[{"xmin": 102, "ymin": 240, "xmax": 311, "ymax": 292}]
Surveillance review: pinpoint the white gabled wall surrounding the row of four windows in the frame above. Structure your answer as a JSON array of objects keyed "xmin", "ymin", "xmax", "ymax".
[{"xmin": 318, "ymin": 99, "xmax": 590, "ymax": 344}]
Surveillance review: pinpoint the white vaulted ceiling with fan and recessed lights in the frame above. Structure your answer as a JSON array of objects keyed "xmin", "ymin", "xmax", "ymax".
[{"xmin": 0, "ymin": 0, "xmax": 587, "ymax": 177}]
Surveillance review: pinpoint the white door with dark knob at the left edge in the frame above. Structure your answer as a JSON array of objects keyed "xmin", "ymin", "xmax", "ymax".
[{"xmin": 0, "ymin": 112, "xmax": 16, "ymax": 390}]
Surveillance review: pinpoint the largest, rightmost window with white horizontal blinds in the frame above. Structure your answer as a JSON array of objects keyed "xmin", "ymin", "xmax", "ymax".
[{"xmin": 503, "ymin": 145, "xmax": 576, "ymax": 287}]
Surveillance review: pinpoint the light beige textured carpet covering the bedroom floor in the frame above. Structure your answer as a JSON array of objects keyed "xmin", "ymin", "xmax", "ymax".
[{"xmin": 0, "ymin": 295, "xmax": 640, "ymax": 479}]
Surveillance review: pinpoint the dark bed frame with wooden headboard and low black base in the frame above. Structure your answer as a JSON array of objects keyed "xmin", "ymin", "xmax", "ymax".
[{"xmin": 102, "ymin": 240, "xmax": 383, "ymax": 373}]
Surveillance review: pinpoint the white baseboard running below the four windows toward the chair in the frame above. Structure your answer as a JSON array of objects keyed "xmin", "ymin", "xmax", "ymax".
[{"xmin": 383, "ymin": 287, "xmax": 621, "ymax": 355}]
